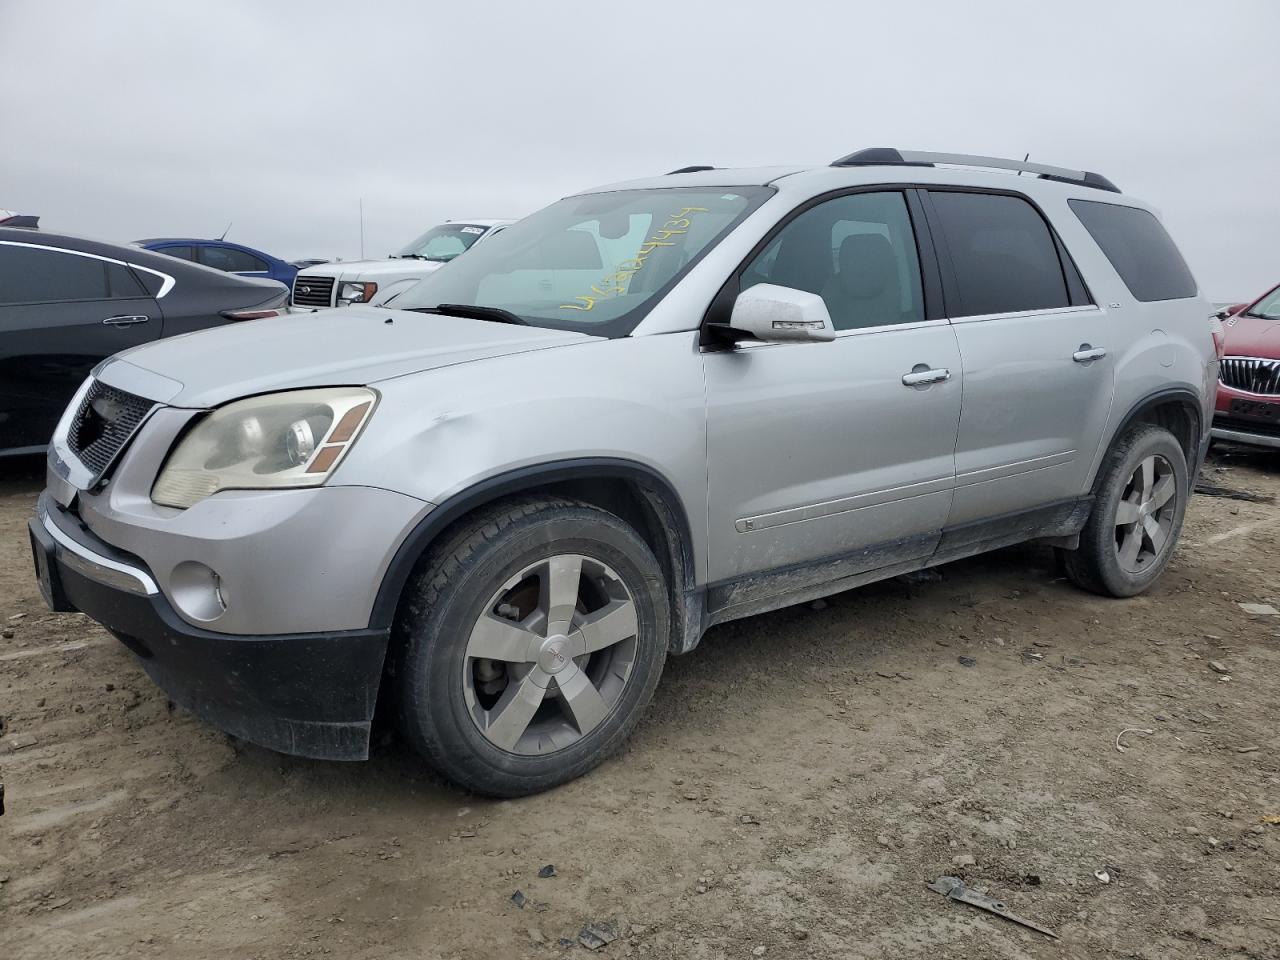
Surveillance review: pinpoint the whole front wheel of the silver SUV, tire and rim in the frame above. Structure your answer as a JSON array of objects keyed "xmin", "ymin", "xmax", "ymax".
[{"xmin": 396, "ymin": 498, "xmax": 671, "ymax": 797}]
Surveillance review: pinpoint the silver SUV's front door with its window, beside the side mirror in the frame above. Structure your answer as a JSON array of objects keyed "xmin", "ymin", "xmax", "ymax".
[{"xmin": 703, "ymin": 191, "xmax": 961, "ymax": 586}]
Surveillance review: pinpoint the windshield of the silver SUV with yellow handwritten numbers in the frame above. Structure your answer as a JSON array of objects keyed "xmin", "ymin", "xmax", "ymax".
[{"xmin": 396, "ymin": 187, "xmax": 772, "ymax": 337}]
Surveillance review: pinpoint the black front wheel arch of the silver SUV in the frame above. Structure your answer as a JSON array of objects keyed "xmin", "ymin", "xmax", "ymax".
[{"xmin": 370, "ymin": 457, "xmax": 701, "ymax": 653}]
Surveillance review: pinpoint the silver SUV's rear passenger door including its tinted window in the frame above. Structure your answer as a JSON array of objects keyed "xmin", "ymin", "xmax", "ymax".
[{"xmin": 924, "ymin": 189, "xmax": 1121, "ymax": 526}]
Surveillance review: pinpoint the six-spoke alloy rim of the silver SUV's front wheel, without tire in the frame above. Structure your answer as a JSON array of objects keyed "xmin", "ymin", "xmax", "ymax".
[{"xmin": 462, "ymin": 554, "xmax": 637, "ymax": 756}]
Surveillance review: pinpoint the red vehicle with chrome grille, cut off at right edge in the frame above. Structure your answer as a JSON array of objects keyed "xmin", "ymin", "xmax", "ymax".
[{"xmin": 1213, "ymin": 287, "xmax": 1280, "ymax": 448}]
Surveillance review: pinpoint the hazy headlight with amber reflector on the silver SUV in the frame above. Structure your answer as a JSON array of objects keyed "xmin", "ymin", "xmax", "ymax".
[{"xmin": 151, "ymin": 387, "xmax": 378, "ymax": 509}]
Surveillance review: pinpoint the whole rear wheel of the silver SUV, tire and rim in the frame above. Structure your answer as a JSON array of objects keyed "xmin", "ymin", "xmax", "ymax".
[{"xmin": 1062, "ymin": 424, "xmax": 1190, "ymax": 596}]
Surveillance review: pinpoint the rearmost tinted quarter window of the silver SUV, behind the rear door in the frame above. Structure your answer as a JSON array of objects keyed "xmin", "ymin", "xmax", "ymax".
[{"xmin": 1066, "ymin": 200, "xmax": 1197, "ymax": 303}]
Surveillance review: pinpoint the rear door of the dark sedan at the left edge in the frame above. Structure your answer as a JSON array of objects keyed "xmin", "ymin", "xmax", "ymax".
[{"xmin": 0, "ymin": 241, "xmax": 161, "ymax": 451}]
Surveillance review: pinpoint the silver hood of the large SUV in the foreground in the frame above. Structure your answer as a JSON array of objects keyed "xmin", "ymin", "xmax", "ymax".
[{"xmin": 95, "ymin": 306, "xmax": 595, "ymax": 407}]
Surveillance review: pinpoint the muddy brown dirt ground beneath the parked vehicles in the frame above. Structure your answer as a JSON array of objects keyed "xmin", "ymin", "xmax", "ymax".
[{"xmin": 0, "ymin": 452, "xmax": 1280, "ymax": 960}]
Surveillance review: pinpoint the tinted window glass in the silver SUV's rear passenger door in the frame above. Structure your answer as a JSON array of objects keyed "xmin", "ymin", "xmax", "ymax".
[{"xmin": 929, "ymin": 191, "xmax": 1071, "ymax": 316}]
